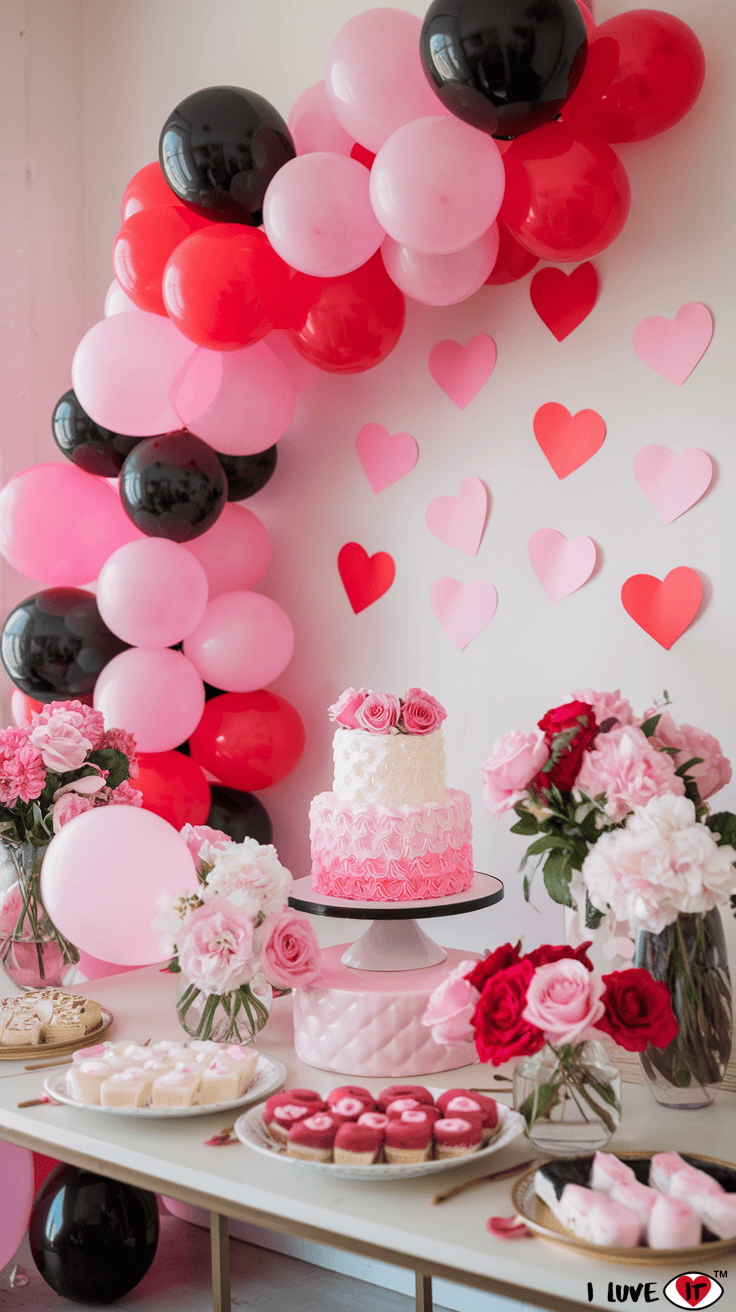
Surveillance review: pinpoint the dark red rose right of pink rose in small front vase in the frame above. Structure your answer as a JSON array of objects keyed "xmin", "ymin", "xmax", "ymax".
[{"xmin": 596, "ymin": 967, "xmax": 678, "ymax": 1052}]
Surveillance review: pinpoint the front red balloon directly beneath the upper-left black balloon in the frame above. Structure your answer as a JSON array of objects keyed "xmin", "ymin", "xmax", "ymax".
[{"xmin": 163, "ymin": 223, "xmax": 290, "ymax": 350}]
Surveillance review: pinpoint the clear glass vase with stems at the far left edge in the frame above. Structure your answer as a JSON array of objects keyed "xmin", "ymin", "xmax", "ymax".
[{"xmin": 0, "ymin": 836, "xmax": 79, "ymax": 989}]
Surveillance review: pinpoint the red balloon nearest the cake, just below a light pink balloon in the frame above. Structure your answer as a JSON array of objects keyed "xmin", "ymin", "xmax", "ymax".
[{"xmin": 189, "ymin": 690, "xmax": 304, "ymax": 792}]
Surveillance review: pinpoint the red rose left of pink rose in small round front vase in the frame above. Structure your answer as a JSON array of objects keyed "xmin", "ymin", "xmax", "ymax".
[{"xmin": 472, "ymin": 960, "xmax": 544, "ymax": 1065}]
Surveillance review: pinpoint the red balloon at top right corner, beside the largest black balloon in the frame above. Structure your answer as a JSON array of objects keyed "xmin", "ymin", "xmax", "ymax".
[{"xmin": 562, "ymin": 9, "xmax": 706, "ymax": 142}]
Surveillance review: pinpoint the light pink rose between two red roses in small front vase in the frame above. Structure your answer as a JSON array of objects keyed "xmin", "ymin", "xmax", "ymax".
[{"xmin": 522, "ymin": 958, "xmax": 606, "ymax": 1046}]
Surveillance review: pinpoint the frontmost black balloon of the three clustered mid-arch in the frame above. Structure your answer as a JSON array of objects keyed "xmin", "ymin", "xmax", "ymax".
[{"xmin": 121, "ymin": 429, "xmax": 227, "ymax": 542}]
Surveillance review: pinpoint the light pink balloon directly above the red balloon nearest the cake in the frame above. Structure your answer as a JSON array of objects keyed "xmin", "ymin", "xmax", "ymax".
[{"xmin": 182, "ymin": 592, "xmax": 294, "ymax": 692}]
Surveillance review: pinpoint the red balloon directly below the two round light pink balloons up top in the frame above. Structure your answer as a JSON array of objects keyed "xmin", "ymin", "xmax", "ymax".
[{"xmin": 289, "ymin": 251, "xmax": 405, "ymax": 374}]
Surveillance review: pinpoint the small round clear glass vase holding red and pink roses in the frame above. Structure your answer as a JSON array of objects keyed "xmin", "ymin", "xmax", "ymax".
[{"xmin": 514, "ymin": 1039, "xmax": 621, "ymax": 1156}]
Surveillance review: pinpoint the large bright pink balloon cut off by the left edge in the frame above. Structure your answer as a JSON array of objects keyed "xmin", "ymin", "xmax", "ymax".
[{"xmin": 0, "ymin": 461, "xmax": 140, "ymax": 588}]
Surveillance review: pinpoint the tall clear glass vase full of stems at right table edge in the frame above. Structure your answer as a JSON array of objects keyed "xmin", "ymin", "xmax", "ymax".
[{"xmin": 634, "ymin": 908, "xmax": 733, "ymax": 1109}]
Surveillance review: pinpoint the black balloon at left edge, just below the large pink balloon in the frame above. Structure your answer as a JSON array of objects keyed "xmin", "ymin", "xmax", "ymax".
[{"xmin": 0, "ymin": 588, "xmax": 129, "ymax": 702}]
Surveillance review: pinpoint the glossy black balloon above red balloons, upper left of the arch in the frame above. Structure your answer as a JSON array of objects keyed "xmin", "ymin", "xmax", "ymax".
[{"xmin": 159, "ymin": 87, "xmax": 296, "ymax": 227}]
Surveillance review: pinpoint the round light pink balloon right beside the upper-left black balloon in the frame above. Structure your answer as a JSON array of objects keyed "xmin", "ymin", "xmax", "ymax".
[{"xmin": 264, "ymin": 151, "xmax": 383, "ymax": 278}]
